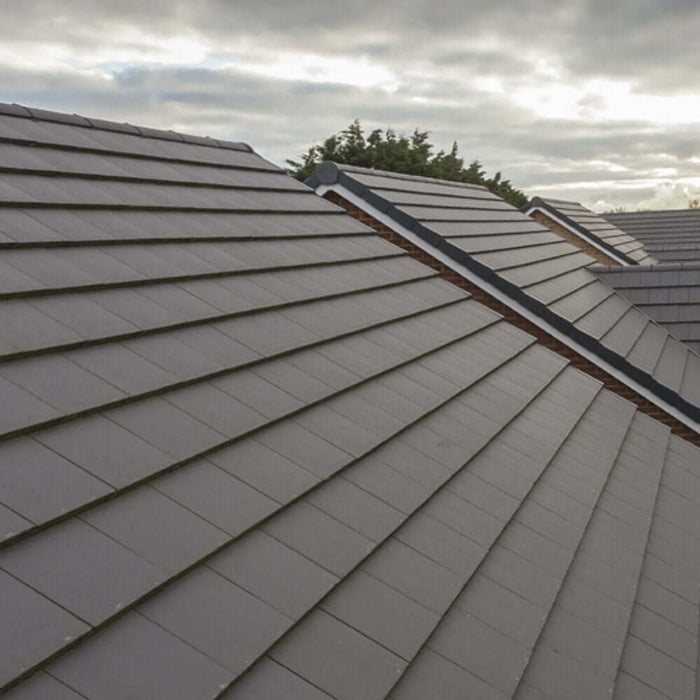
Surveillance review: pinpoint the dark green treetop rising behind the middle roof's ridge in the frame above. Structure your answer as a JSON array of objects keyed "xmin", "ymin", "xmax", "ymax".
[{"xmin": 287, "ymin": 119, "xmax": 527, "ymax": 207}]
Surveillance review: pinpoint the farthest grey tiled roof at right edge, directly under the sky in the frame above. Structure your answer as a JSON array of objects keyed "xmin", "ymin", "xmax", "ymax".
[{"xmin": 603, "ymin": 209, "xmax": 700, "ymax": 262}]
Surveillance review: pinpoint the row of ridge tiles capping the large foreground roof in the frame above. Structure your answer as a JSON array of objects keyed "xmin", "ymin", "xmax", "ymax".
[{"xmin": 0, "ymin": 102, "xmax": 255, "ymax": 153}]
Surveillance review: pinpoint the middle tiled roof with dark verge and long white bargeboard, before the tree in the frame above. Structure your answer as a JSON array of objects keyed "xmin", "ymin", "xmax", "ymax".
[{"xmin": 308, "ymin": 163, "xmax": 700, "ymax": 422}]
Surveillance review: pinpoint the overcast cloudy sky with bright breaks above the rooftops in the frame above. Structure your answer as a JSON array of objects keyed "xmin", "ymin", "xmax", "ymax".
[{"xmin": 0, "ymin": 0, "xmax": 700, "ymax": 210}]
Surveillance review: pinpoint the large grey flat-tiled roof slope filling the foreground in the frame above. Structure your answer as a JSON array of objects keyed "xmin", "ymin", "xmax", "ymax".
[{"xmin": 0, "ymin": 107, "xmax": 700, "ymax": 700}]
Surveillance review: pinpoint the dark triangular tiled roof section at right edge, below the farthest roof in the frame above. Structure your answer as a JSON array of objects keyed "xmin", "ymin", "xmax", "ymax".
[{"xmin": 594, "ymin": 260, "xmax": 700, "ymax": 353}]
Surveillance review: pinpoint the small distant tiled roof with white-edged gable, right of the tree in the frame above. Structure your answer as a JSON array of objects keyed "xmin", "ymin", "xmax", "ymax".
[{"xmin": 523, "ymin": 197, "xmax": 656, "ymax": 265}]
